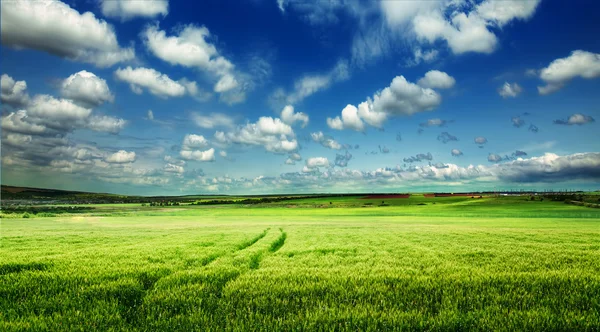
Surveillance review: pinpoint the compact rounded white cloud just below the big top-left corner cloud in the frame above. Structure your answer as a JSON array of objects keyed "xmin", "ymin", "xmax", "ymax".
[{"xmin": 61, "ymin": 70, "xmax": 115, "ymax": 107}]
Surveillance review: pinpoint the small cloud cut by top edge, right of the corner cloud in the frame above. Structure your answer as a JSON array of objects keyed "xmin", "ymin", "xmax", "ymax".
[{"xmin": 101, "ymin": 0, "xmax": 169, "ymax": 21}]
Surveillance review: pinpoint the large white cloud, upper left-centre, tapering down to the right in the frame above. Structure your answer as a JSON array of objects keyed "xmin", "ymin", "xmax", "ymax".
[{"xmin": 142, "ymin": 25, "xmax": 238, "ymax": 93}]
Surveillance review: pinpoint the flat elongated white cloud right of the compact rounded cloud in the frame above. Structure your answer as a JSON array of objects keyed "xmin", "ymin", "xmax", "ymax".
[{"xmin": 115, "ymin": 67, "xmax": 197, "ymax": 98}]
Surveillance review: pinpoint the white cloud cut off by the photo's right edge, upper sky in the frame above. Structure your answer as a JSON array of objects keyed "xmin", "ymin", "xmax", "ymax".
[{"xmin": 538, "ymin": 50, "xmax": 600, "ymax": 95}]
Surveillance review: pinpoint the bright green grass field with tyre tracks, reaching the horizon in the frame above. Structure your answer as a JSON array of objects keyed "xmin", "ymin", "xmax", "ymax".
[{"xmin": 0, "ymin": 196, "xmax": 600, "ymax": 331}]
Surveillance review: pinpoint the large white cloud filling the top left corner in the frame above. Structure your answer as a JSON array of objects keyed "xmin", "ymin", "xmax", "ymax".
[{"xmin": 0, "ymin": 0, "xmax": 135, "ymax": 67}]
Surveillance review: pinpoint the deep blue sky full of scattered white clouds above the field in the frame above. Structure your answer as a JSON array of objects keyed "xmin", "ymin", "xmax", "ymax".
[{"xmin": 0, "ymin": 0, "xmax": 600, "ymax": 195}]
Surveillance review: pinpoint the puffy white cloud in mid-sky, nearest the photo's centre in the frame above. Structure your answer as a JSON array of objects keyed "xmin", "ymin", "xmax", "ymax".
[{"xmin": 214, "ymin": 116, "xmax": 298, "ymax": 153}]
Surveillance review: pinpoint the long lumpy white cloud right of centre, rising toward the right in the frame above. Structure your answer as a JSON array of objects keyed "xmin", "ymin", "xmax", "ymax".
[{"xmin": 327, "ymin": 76, "xmax": 442, "ymax": 131}]
